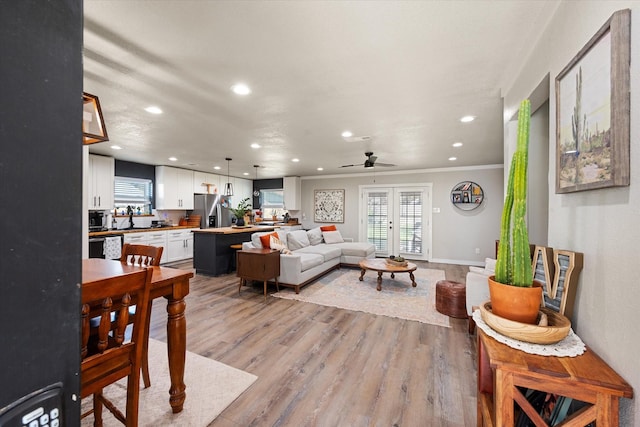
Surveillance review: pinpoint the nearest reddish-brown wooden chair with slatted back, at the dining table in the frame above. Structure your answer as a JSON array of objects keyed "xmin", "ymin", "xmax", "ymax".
[{"xmin": 80, "ymin": 268, "xmax": 153, "ymax": 426}]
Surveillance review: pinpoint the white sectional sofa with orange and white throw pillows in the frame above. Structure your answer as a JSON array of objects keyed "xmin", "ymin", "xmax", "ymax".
[{"xmin": 242, "ymin": 227, "xmax": 375, "ymax": 293}]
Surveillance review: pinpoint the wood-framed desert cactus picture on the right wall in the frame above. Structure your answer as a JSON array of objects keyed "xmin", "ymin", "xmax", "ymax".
[{"xmin": 555, "ymin": 9, "xmax": 631, "ymax": 194}]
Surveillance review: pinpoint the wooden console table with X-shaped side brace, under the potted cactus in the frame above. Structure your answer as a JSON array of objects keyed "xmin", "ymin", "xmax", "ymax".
[{"xmin": 478, "ymin": 329, "xmax": 633, "ymax": 427}]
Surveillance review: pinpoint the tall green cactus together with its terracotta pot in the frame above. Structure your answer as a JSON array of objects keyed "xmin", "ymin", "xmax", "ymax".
[{"xmin": 489, "ymin": 99, "xmax": 542, "ymax": 324}]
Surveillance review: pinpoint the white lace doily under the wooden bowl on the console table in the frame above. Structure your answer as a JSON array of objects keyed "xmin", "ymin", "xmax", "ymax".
[{"xmin": 473, "ymin": 310, "xmax": 586, "ymax": 357}]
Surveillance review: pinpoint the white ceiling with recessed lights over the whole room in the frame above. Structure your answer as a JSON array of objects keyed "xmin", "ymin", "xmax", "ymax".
[{"xmin": 84, "ymin": 0, "xmax": 557, "ymax": 179}]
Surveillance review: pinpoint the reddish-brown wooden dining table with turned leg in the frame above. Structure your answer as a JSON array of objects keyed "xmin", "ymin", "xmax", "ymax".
[{"xmin": 82, "ymin": 258, "xmax": 193, "ymax": 413}]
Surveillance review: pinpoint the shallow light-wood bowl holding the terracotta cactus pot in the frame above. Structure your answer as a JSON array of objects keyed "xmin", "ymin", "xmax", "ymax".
[{"xmin": 480, "ymin": 301, "xmax": 571, "ymax": 344}]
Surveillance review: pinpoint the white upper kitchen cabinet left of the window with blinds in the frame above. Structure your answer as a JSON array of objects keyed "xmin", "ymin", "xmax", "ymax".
[{"xmin": 87, "ymin": 154, "xmax": 115, "ymax": 210}]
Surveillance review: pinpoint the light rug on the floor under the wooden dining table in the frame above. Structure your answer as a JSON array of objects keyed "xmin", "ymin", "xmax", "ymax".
[{"xmin": 82, "ymin": 339, "xmax": 258, "ymax": 427}]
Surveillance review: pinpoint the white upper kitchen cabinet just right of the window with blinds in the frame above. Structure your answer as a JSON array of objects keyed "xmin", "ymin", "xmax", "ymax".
[{"xmin": 156, "ymin": 166, "xmax": 193, "ymax": 210}]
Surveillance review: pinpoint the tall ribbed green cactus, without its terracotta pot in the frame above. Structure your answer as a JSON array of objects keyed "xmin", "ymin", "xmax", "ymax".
[{"xmin": 495, "ymin": 99, "xmax": 533, "ymax": 287}]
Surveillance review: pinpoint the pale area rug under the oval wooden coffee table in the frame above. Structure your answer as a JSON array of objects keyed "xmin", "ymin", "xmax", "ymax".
[{"xmin": 272, "ymin": 268, "xmax": 450, "ymax": 327}]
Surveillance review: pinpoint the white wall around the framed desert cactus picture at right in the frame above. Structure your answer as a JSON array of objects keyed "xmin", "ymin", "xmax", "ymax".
[{"xmin": 504, "ymin": 0, "xmax": 640, "ymax": 426}]
